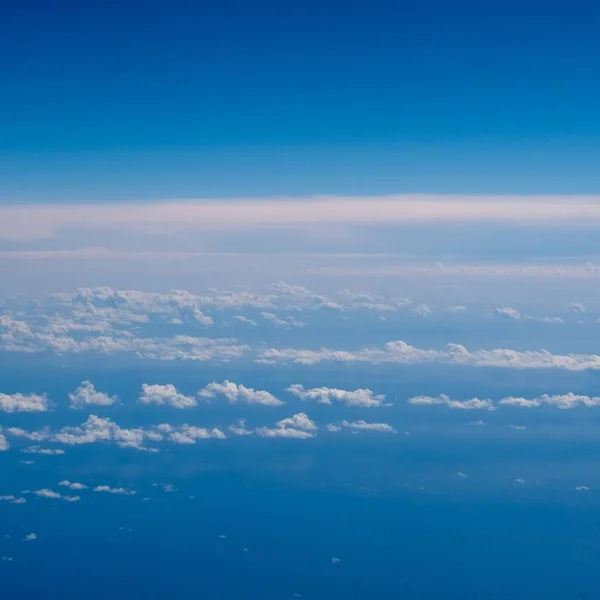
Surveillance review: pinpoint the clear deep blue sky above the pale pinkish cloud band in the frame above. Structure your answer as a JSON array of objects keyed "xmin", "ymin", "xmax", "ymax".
[{"xmin": 0, "ymin": 0, "xmax": 600, "ymax": 201}]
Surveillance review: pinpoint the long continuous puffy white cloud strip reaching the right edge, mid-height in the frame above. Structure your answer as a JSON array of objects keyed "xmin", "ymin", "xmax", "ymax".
[{"xmin": 257, "ymin": 340, "xmax": 600, "ymax": 371}]
